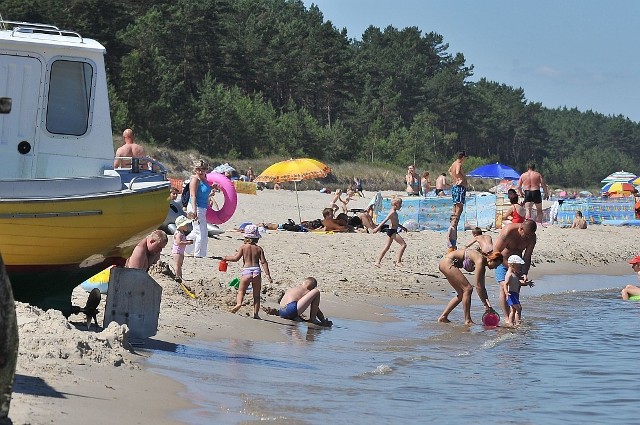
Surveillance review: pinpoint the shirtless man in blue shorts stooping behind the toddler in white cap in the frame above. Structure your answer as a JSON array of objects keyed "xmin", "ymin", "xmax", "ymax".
[{"xmin": 493, "ymin": 220, "xmax": 538, "ymax": 318}]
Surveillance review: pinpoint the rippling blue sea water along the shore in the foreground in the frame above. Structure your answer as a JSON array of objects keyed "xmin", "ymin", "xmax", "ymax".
[{"xmin": 149, "ymin": 275, "xmax": 640, "ymax": 425}]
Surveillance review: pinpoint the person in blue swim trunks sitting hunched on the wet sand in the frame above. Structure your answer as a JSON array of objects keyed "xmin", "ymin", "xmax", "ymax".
[{"xmin": 267, "ymin": 277, "xmax": 333, "ymax": 326}]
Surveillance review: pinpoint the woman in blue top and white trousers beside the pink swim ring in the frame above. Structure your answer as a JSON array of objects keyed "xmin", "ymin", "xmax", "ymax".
[{"xmin": 187, "ymin": 159, "xmax": 211, "ymax": 258}]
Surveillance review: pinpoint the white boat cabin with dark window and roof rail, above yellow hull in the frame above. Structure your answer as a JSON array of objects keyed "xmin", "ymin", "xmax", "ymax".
[{"xmin": 0, "ymin": 20, "xmax": 114, "ymax": 180}]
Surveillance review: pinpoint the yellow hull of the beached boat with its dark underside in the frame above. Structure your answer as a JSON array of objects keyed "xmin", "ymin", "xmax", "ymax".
[{"xmin": 0, "ymin": 182, "xmax": 169, "ymax": 312}]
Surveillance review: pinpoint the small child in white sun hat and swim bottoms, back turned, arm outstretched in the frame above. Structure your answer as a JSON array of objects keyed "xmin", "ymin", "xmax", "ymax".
[{"xmin": 222, "ymin": 224, "xmax": 273, "ymax": 319}]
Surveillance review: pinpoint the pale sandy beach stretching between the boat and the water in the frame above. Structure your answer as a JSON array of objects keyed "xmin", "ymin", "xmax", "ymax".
[{"xmin": 10, "ymin": 190, "xmax": 640, "ymax": 425}]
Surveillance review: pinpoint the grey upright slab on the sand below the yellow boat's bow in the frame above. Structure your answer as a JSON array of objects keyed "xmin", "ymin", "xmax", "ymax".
[{"xmin": 102, "ymin": 267, "xmax": 162, "ymax": 338}]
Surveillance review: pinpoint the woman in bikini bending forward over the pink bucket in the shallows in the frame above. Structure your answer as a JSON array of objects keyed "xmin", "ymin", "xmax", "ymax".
[{"xmin": 438, "ymin": 249, "xmax": 502, "ymax": 325}]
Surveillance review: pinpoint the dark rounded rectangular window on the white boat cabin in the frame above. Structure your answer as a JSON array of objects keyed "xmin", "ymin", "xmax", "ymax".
[{"xmin": 47, "ymin": 60, "xmax": 93, "ymax": 136}]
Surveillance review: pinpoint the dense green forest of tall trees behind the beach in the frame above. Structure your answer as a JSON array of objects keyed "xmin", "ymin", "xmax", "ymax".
[{"xmin": 6, "ymin": 0, "xmax": 640, "ymax": 186}]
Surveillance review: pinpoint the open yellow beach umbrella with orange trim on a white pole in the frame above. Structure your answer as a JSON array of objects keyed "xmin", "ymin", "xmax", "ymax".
[{"xmin": 253, "ymin": 158, "xmax": 331, "ymax": 222}]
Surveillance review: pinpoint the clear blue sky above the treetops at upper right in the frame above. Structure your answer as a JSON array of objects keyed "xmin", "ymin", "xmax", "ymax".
[{"xmin": 303, "ymin": 0, "xmax": 640, "ymax": 122}]
